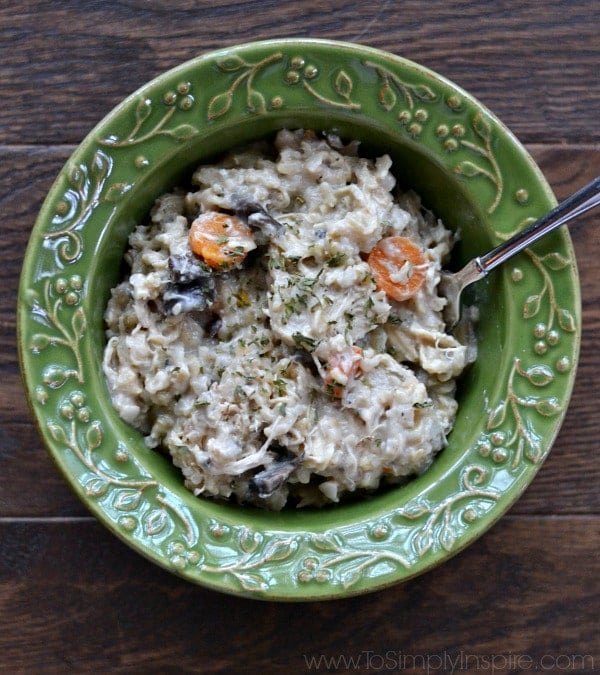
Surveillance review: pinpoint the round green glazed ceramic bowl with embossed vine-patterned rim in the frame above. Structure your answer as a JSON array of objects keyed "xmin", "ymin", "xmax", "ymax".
[{"xmin": 18, "ymin": 39, "xmax": 580, "ymax": 600}]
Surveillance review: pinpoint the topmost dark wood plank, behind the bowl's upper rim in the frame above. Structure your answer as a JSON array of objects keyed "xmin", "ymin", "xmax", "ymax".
[{"xmin": 0, "ymin": 0, "xmax": 600, "ymax": 144}]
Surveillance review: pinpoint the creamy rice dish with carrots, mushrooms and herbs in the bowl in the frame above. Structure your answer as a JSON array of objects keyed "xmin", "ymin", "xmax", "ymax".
[{"xmin": 103, "ymin": 131, "xmax": 472, "ymax": 509}]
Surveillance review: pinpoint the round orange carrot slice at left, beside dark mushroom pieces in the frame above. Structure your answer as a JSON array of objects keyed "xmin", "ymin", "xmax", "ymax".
[{"xmin": 189, "ymin": 211, "xmax": 256, "ymax": 269}]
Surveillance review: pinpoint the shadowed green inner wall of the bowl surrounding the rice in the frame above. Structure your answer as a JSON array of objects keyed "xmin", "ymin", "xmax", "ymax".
[{"xmin": 84, "ymin": 111, "xmax": 496, "ymax": 508}]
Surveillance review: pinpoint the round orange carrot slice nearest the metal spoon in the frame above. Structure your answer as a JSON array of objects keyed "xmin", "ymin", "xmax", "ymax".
[{"xmin": 367, "ymin": 236, "xmax": 427, "ymax": 301}]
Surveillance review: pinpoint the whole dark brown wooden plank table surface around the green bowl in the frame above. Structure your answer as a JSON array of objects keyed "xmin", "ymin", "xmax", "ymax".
[{"xmin": 0, "ymin": 0, "xmax": 600, "ymax": 673}]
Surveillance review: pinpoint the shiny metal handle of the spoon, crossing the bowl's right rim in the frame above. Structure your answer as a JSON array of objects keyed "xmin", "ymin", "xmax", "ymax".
[{"xmin": 475, "ymin": 176, "xmax": 600, "ymax": 276}]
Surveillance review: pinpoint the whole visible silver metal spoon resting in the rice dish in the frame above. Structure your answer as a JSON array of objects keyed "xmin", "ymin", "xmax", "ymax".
[{"xmin": 439, "ymin": 176, "xmax": 600, "ymax": 328}]
